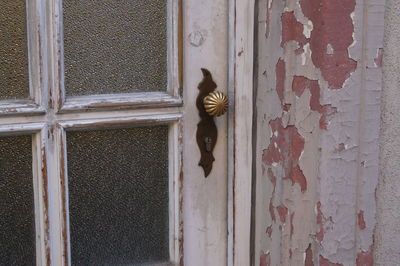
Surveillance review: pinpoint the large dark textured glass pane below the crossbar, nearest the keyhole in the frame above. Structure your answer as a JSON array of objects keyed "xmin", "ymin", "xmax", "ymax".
[{"xmin": 67, "ymin": 126, "xmax": 169, "ymax": 265}]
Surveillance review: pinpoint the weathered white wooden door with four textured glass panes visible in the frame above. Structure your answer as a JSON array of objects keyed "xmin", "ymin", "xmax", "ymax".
[{"xmin": 0, "ymin": 0, "xmax": 233, "ymax": 265}]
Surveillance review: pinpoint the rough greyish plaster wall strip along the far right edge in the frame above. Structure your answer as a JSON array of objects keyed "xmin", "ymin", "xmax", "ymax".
[{"xmin": 375, "ymin": 0, "xmax": 400, "ymax": 265}]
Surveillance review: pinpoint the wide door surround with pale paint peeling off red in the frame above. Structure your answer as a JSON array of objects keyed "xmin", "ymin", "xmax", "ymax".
[{"xmin": 255, "ymin": 0, "xmax": 385, "ymax": 266}]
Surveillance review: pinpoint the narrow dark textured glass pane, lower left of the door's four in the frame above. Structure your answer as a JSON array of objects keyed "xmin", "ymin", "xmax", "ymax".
[{"xmin": 0, "ymin": 136, "xmax": 36, "ymax": 266}]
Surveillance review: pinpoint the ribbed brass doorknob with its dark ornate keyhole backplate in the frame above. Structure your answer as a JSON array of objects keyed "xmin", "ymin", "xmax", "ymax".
[{"xmin": 196, "ymin": 68, "xmax": 228, "ymax": 177}]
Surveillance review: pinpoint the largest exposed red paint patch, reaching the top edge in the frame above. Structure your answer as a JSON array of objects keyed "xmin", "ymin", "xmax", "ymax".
[{"xmin": 300, "ymin": 0, "xmax": 357, "ymax": 89}]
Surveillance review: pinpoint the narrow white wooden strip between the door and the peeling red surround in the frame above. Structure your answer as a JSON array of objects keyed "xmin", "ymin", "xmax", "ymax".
[{"xmin": 229, "ymin": 0, "xmax": 254, "ymax": 266}]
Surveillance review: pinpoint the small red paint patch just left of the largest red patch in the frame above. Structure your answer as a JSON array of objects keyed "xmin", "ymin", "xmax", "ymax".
[{"xmin": 281, "ymin": 11, "xmax": 307, "ymax": 47}]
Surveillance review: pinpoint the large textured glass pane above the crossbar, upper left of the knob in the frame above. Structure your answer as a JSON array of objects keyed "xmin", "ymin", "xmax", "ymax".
[{"xmin": 63, "ymin": 0, "xmax": 167, "ymax": 95}]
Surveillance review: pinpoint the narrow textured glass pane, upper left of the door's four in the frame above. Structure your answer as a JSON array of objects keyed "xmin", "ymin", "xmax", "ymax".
[{"xmin": 0, "ymin": 0, "xmax": 29, "ymax": 99}]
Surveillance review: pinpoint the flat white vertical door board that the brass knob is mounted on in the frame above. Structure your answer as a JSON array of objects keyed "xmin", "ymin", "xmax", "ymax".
[{"xmin": 183, "ymin": 0, "xmax": 228, "ymax": 266}]
